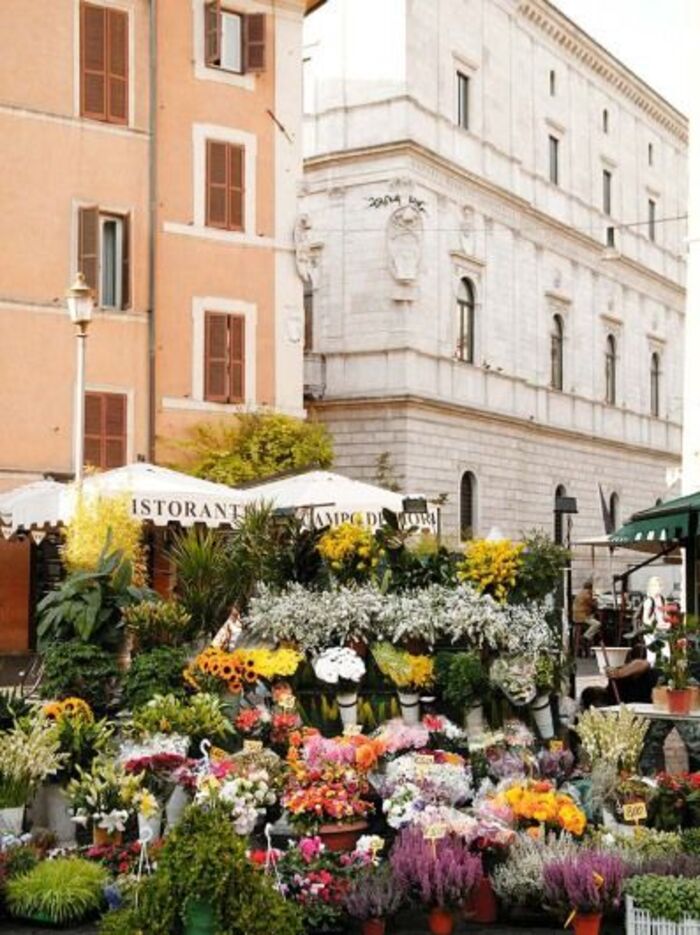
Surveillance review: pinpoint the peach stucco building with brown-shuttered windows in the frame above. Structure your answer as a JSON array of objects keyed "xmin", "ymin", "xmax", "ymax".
[{"xmin": 0, "ymin": 0, "xmax": 318, "ymax": 652}]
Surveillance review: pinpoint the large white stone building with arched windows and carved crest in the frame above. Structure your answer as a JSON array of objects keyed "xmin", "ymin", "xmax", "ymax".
[{"xmin": 296, "ymin": 0, "xmax": 687, "ymax": 537}]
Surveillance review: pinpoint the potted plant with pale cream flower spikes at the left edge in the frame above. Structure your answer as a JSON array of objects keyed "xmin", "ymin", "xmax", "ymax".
[{"xmin": 0, "ymin": 718, "xmax": 64, "ymax": 835}]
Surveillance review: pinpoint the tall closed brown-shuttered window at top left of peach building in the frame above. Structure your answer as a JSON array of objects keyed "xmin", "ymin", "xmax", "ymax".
[{"xmin": 80, "ymin": 3, "xmax": 129, "ymax": 124}]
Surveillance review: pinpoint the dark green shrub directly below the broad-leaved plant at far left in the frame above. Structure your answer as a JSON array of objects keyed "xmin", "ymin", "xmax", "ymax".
[{"xmin": 39, "ymin": 640, "xmax": 119, "ymax": 712}]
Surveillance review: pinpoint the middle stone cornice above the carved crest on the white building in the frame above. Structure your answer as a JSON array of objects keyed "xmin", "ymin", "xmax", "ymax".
[{"xmin": 304, "ymin": 140, "xmax": 685, "ymax": 304}]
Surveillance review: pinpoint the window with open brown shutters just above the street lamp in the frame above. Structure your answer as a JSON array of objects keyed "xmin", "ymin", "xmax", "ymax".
[{"xmin": 78, "ymin": 207, "xmax": 131, "ymax": 309}]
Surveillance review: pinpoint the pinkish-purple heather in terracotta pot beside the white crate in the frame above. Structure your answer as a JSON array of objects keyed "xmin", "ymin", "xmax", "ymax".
[{"xmin": 543, "ymin": 850, "xmax": 629, "ymax": 913}]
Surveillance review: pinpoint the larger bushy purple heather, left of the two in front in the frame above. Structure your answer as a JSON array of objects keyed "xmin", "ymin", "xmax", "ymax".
[{"xmin": 390, "ymin": 827, "xmax": 483, "ymax": 909}]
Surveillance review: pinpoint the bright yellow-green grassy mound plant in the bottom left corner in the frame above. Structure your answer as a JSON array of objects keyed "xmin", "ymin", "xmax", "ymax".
[{"xmin": 7, "ymin": 857, "xmax": 107, "ymax": 925}]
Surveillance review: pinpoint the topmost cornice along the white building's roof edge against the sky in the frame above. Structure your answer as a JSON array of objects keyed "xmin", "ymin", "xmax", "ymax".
[{"xmin": 518, "ymin": 0, "xmax": 688, "ymax": 144}]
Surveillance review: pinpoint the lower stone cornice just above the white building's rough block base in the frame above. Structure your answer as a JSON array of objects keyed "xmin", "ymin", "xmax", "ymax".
[{"xmin": 308, "ymin": 393, "xmax": 681, "ymax": 465}]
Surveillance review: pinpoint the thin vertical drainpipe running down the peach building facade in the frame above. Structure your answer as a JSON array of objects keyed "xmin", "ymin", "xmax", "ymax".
[{"xmin": 147, "ymin": 0, "xmax": 158, "ymax": 462}]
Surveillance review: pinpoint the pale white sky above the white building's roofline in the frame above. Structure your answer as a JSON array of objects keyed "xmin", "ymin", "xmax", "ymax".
[{"xmin": 553, "ymin": 0, "xmax": 688, "ymax": 114}]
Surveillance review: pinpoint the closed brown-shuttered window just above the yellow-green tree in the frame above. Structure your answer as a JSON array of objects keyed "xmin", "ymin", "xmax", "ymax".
[{"xmin": 204, "ymin": 312, "xmax": 245, "ymax": 403}]
